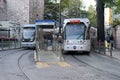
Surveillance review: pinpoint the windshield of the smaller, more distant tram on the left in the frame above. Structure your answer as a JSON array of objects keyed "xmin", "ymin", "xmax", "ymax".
[{"xmin": 23, "ymin": 27, "xmax": 35, "ymax": 42}]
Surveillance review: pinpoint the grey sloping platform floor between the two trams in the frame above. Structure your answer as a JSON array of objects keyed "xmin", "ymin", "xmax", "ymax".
[{"xmin": 34, "ymin": 46, "xmax": 64, "ymax": 62}]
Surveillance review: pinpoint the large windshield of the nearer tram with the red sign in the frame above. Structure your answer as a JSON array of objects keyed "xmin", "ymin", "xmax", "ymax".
[{"xmin": 65, "ymin": 24, "xmax": 85, "ymax": 40}]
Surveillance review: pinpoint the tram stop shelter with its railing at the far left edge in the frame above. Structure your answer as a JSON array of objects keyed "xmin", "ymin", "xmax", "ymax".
[{"xmin": 0, "ymin": 21, "xmax": 21, "ymax": 50}]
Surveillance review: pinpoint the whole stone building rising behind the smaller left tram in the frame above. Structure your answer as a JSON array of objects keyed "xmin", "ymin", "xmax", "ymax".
[{"xmin": 0, "ymin": 0, "xmax": 44, "ymax": 26}]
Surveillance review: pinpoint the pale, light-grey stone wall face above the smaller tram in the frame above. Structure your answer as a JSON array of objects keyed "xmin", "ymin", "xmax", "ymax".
[{"xmin": 7, "ymin": 0, "xmax": 29, "ymax": 25}]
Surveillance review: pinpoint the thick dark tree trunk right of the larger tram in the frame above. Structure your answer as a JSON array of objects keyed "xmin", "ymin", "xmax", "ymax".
[{"xmin": 96, "ymin": 0, "xmax": 105, "ymax": 42}]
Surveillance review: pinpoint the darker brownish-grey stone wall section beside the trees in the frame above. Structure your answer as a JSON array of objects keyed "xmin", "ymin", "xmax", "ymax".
[{"xmin": 29, "ymin": 0, "xmax": 44, "ymax": 23}]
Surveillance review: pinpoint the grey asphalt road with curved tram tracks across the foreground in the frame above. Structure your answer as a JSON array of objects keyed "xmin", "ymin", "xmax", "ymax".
[{"xmin": 0, "ymin": 49, "xmax": 120, "ymax": 80}]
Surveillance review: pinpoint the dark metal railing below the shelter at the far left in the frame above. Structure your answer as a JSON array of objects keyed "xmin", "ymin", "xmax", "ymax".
[{"xmin": 0, "ymin": 38, "xmax": 21, "ymax": 50}]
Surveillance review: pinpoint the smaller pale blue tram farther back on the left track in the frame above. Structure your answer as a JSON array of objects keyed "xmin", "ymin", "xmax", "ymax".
[{"xmin": 21, "ymin": 24, "xmax": 36, "ymax": 48}]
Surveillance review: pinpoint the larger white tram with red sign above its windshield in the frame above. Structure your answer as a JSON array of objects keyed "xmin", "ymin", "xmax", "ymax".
[{"xmin": 62, "ymin": 18, "xmax": 91, "ymax": 54}]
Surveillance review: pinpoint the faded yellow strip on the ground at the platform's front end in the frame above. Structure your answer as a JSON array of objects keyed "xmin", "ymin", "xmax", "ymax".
[{"xmin": 36, "ymin": 62, "xmax": 71, "ymax": 68}]
